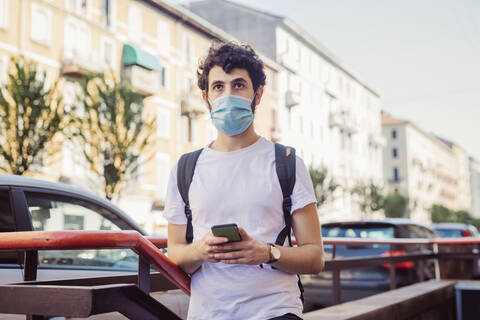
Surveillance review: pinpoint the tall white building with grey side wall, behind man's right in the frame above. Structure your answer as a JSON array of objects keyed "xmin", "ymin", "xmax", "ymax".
[{"xmin": 189, "ymin": 0, "xmax": 385, "ymax": 221}]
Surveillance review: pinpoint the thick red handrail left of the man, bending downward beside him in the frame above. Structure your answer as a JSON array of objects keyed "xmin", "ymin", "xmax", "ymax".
[{"xmin": 0, "ymin": 230, "xmax": 190, "ymax": 295}]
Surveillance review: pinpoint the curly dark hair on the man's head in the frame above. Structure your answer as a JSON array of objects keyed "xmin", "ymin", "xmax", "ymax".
[{"xmin": 197, "ymin": 42, "xmax": 266, "ymax": 93}]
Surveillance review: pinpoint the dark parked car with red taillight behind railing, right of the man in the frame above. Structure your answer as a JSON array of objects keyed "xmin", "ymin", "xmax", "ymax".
[{"xmin": 302, "ymin": 219, "xmax": 436, "ymax": 312}]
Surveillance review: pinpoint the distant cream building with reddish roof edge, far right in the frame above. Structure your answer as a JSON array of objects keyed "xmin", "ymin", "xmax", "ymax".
[{"xmin": 382, "ymin": 113, "xmax": 471, "ymax": 223}]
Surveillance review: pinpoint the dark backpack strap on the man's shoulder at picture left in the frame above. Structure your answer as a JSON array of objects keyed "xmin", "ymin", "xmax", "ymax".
[{"xmin": 177, "ymin": 149, "xmax": 203, "ymax": 243}]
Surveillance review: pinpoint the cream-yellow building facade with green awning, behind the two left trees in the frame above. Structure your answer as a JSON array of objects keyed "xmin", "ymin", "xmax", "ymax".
[{"xmin": 0, "ymin": 0, "xmax": 282, "ymax": 232}]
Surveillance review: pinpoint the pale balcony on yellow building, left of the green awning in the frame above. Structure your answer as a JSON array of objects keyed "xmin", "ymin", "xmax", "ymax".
[{"xmin": 61, "ymin": 48, "xmax": 105, "ymax": 78}]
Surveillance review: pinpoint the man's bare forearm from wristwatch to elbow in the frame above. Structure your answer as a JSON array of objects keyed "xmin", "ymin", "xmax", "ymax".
[{"xmin": 272, "ymin": 244, "xmax": 325, "ymax": 274}]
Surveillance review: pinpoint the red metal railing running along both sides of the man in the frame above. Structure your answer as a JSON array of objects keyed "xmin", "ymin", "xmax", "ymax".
[{"xmin": 0, "ymin": 231, "xmax": 480, "ymax": 303}]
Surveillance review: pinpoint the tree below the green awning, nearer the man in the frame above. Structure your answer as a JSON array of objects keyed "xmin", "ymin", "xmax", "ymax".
[{"xmin": 75, "ymin": 74, "xmax": 155, "ymax": 199}]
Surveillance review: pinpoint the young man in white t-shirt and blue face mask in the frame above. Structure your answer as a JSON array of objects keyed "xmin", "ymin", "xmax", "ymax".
[{"xmin": 165, "ymin": 43, "xmax": 324, "ymax": 320}]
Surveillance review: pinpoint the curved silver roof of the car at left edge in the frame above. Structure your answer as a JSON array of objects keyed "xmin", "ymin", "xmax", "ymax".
[{"xmin": 0, "ymin": 174, "xmax": 146, "ymax": 234}]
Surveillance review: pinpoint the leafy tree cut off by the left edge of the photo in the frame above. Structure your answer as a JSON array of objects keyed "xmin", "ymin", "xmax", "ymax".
[{"xmin": 0, "ymin": 58, "xmax": 69, "ymax": 175}]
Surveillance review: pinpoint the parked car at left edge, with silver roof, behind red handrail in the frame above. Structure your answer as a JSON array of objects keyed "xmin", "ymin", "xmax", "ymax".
[{"xmin": 0, "ymin": 175, "xmax": 146, "ymax": 284}]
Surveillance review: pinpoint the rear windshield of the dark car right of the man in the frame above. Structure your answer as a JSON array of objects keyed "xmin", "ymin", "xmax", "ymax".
[{"xmin": 322, "ymin": 225, "xmax": 394, "ymax": 240}]
